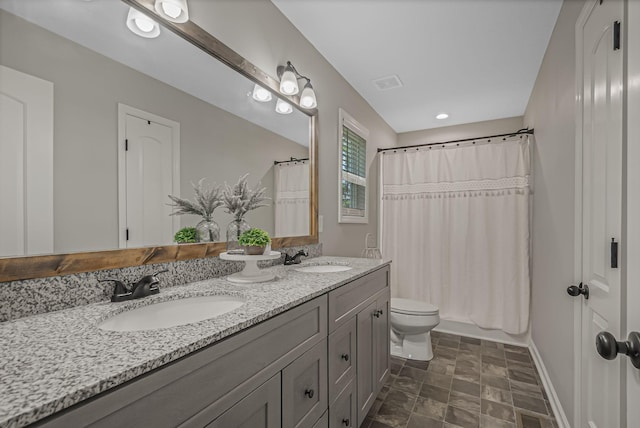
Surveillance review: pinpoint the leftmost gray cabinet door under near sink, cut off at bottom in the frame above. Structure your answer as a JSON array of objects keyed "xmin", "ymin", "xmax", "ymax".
[{"xmin": 207, "ymin": 373, "xmax": 282, "ymax": 428}]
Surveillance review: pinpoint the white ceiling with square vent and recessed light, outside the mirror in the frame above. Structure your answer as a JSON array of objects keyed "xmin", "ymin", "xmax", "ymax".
[{"xmin": 271, "ymin": 0, "xmax": 562, "ymax": 132}]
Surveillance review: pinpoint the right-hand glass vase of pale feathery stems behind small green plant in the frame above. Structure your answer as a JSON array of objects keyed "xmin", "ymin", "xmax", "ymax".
[{"xmin": 222, "ymin": 174, "xmax": 270, "ymax": 252}]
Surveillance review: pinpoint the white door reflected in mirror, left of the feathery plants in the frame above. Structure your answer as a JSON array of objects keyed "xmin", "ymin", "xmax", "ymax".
[{"xmin": 124, "ymin": 114, "xmax": 175, "ymax": 248}]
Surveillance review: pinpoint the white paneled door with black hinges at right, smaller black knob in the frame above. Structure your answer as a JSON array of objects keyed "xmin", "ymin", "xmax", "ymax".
[{"xmin": 577, "ymin": 0, "xmax": 623, "ymax": 428}]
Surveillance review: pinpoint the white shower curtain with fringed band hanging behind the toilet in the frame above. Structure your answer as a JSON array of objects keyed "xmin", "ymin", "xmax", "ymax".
[{"xmin": 380, "ymin": 136, "xmax": 530, "ymax": 334}]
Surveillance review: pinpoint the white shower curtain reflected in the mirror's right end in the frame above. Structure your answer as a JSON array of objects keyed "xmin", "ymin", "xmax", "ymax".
[{"xmin": 273, "ymin": 161, "xmax": 309, "ymax": 236}]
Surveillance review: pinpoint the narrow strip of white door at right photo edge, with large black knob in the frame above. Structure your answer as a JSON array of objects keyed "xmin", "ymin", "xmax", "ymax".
[{"xmin": 618, "ymin": 0, "xmax": 640, "ymax": 428}]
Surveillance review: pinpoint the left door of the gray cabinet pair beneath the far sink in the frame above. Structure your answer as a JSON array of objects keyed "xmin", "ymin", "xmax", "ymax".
[{"xmin": 356, "ymin": 301, "xmax": 378, "ymax": 423}]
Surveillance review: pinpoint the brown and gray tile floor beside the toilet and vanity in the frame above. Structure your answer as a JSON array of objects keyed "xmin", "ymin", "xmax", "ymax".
[{"xmin": 361, "ymin": 332, "xmax": 558, "ymax": 428}]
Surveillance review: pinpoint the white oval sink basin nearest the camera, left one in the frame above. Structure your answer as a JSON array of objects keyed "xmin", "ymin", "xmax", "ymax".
[{"xmin": 98, "ymin": 295, "xmax": 245, "ymax": 331}]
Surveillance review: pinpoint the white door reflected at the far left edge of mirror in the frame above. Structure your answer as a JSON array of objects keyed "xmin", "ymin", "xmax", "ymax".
[{"xmin": 0, "ymin": 65, "xmax": 53, "ymax": 257}]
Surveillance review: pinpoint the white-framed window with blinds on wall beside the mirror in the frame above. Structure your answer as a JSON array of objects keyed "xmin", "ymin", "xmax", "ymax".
[{"xmin": 338, "ymin": 109, "xmax": 369, "ymax": 223}]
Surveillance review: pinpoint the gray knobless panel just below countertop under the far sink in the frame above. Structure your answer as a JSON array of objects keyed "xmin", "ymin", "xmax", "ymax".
[{"xmin": 329, "ymin": 266, "xmax": 389, "ymax": 332}]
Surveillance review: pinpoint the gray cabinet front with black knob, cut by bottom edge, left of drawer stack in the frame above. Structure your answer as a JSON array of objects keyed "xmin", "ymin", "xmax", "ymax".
[{"xmin": 282, "ymin": 338, "xmax": 327, "ymax": 428}]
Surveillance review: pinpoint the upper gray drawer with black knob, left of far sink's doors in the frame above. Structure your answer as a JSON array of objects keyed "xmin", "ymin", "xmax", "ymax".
[{"xmin": 329, "ymin": 317, "xmax": 356, "ymax": 405}]
